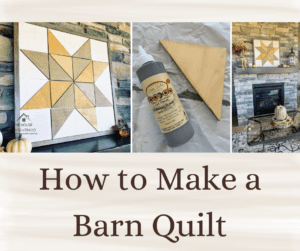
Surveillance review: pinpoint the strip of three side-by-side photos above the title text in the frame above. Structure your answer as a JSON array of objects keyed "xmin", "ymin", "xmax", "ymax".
[{"xmin": 0, "ymin": 22, "xmax": 300, "ymax": 153}]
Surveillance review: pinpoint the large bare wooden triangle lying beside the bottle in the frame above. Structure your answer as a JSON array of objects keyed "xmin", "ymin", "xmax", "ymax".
[{"xmin": 160, "ymin": 40, "xmax": 226, "ymax": 120}]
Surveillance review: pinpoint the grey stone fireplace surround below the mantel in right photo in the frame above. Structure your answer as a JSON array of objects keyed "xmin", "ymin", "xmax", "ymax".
[{"xmin": 233, "ymin": 68, "xmax": 298, "ymax": 126}]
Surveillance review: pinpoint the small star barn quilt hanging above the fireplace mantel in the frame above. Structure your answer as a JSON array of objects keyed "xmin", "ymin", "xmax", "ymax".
[{"xmin": 253, "ymin": 40, "xmax": 280, "ymax": 67}]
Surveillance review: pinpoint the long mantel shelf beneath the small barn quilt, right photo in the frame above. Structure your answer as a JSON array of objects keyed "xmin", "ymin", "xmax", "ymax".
[{"xmin": 233, "ymin": 67, "xmax": 299, "ymax": 74}]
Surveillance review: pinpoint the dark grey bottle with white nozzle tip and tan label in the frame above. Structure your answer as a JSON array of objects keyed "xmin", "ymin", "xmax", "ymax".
[{"xmin": 135, "ymin": 46, "xmax": 194, "ymax": 147}]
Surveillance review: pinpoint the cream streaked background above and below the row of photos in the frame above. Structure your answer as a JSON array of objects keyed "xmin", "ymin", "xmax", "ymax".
[{"xmin": 0, "ymin": 0, "xmax": 300, "ymax": 251}]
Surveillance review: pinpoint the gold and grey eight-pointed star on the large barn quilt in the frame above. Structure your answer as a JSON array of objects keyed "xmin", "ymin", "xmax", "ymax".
[{"xmin": 20, "ymin": 23, "xmax": 113, "ymax": 143}]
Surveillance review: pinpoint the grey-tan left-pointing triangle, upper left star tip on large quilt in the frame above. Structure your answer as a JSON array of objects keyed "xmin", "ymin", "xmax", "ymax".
[{"xmin": 21, "ymin": 50, "xmax": 49, "ymax": 78}]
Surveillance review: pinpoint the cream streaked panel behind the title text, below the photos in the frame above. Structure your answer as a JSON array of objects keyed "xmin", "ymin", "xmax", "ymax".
[{"xmin": 0, "ymin": 154, "xmax": 300, "ymax": 251}]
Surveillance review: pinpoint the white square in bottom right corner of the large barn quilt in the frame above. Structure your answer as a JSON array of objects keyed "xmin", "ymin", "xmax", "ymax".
[{"xmin": 96, "ymin": 106, "xmax": 116, "ymax": 132}]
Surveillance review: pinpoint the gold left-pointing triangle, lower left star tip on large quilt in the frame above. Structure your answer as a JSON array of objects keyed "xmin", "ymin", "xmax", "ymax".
[{"xmin": 21, "ymin": 82, "xmax": 51, "ymax": 110}]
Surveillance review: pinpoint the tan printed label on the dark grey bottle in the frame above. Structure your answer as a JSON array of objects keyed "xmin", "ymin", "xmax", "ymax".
[{"xmin": 141, "ymin": 73, "xmax": 189, "ymax": 133}]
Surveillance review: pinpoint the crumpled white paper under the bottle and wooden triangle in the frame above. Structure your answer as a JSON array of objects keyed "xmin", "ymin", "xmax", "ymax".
[{"xmin": 132, "ymin": 23, "xmax": 230, "ymax": 152}]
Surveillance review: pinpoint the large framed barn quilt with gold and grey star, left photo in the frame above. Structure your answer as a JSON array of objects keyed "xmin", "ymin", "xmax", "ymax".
[{"xmin": 14, "ymin": 23, "xmax": 117, "ymax": 147}]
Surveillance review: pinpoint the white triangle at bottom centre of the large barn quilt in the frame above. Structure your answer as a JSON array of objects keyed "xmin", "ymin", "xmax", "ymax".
[{"xmin": 54, "ymin": 109, "xmax": 97, "ymax": 139}]
